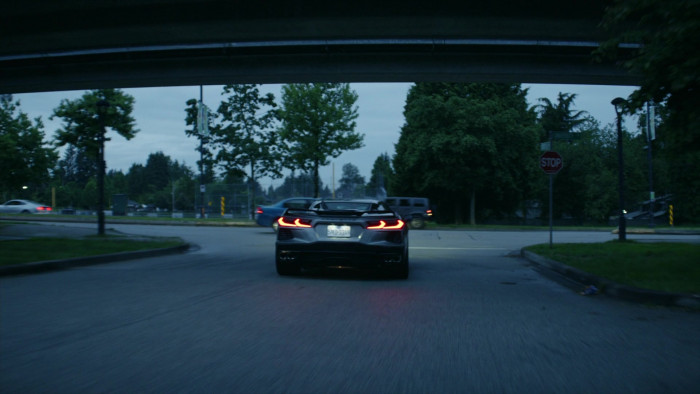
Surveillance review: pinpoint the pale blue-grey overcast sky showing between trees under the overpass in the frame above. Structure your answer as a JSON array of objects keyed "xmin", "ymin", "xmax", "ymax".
[{"xmin": 13, "ymin": 83, "xmax": 634, "ymax": 189}]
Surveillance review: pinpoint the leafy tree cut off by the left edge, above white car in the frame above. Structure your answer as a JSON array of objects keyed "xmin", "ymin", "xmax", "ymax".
[{"xmin": 0, "ymin": 95, "xmax": 58, "ymax": 201}]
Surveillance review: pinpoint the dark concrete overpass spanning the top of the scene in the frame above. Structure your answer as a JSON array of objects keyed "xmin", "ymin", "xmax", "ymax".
[{"xmin": 0, "ymin": 0, "xmax": 637, "ymax": 93}]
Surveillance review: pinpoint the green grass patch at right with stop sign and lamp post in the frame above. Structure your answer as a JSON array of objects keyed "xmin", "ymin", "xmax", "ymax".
[{"xmin": 526, "ymin": 241, "xmax": 700, "ymax": 294}]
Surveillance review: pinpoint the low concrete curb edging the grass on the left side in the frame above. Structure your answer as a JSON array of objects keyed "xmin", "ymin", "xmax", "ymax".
[{"xmin": 0, "ymin": 243, "xmax": 190, "ymax": 276}]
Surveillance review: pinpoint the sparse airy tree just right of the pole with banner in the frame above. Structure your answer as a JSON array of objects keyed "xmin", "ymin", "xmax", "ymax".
[{"xmin": 213, "ymin": 85, "xmax": 282, "ymax": 215}]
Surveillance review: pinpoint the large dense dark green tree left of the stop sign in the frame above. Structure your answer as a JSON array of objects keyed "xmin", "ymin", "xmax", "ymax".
[{"xmin": 392, "ymin": 83, "xmax": 538, "ymax": 223}]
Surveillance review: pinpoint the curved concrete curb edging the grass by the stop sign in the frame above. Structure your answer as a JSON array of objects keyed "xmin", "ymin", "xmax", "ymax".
[{"xmin": 520, "ymin": 248, "xmax": 700, "ymax": 310}]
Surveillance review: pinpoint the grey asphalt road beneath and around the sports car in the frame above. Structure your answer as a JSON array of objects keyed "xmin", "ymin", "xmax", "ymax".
[{"xmin": 0, "ymin": 225, "xmax": 700, "ymax": 393}]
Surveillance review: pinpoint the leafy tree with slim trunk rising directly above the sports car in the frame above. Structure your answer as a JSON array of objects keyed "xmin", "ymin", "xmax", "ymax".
[{"xmin": 280, "ymin": 83, "xmax": 364, "ymax": 197}]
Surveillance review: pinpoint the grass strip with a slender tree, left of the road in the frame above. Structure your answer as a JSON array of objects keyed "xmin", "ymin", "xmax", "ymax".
[{"xmin": 0, "ymin": 236, "xmax": 184, "ymax": 265}]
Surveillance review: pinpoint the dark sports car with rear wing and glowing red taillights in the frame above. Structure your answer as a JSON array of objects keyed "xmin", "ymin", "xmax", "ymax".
[{"xmin": 275, "ymin": 200, "xmax": 408, "ymax": 279}]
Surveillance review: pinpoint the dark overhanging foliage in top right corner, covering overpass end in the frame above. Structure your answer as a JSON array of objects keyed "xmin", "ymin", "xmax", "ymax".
[{"xmin": 596, "ymin": 0, "xmax": 700, "ymax": 152}]
